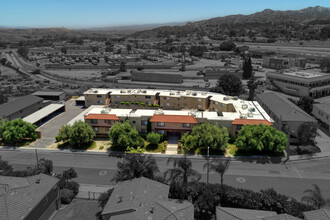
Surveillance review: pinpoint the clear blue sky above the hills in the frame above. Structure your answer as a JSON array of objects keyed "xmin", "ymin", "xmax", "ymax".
[{"xmin": 0, "ymin": 0, "xmax": 330, "ymax": 28}]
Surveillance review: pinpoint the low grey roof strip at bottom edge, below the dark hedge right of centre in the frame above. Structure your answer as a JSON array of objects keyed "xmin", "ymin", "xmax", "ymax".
[{"xmin": 216, "ymin": 206, "xmax": 277, "ymax": 220}]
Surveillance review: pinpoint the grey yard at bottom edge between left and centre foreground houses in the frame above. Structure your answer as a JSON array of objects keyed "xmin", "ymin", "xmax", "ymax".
[{"xmin": 51, "ymin": 199, "xmax": 101, "ymax": 220}]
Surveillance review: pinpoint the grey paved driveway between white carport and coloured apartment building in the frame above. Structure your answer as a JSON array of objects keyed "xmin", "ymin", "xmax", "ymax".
[{"xmin": 30, "ymin": 100, "xmax": 84, "ymax": 148}]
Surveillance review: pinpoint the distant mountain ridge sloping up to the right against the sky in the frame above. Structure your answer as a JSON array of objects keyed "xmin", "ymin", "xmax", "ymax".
[{"xmin": 132, "ymin": 6, "xmax": 330, "ymax": 37}]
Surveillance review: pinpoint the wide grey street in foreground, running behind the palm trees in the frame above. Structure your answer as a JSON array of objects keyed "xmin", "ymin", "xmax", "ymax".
[{"xmin": 0, "ymin": 150, "xmax": 330, "ymax": 199}]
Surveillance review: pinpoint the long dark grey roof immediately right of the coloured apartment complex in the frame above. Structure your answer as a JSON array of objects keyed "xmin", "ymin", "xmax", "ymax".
[{"xmin": 257, "ymin": 92, "xmax": 316, "ymax": 122}]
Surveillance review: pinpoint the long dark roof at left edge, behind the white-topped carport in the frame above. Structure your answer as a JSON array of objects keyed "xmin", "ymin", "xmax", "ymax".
[{"xmin": 0, "ymin": 95, "xmax": 43, "ymax": 118}]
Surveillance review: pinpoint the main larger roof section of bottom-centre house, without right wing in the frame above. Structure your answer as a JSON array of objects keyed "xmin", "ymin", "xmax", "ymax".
[{"xmin": 102, "ymin": 177, "xmax": 169, "ymax": 220}]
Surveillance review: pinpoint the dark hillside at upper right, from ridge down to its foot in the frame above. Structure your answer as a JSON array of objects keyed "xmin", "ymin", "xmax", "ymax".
[{"xmin": 132, "ymin": 6, "xmax": 330, "ymax": 39}]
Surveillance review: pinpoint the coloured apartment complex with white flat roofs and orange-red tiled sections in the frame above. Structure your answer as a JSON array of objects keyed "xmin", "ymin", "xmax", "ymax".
[{"xmin": 84, "ymin": 89, "xmax": 273, "ymax": 136}]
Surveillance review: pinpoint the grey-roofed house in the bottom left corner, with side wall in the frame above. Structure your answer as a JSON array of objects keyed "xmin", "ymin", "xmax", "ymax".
[{"xmin": 0, "ymin": 174, "xmax": 61, "ymax": 220}]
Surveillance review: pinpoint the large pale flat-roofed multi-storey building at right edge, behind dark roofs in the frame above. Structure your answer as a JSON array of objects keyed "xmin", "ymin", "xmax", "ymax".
[{"xmin": 266, "ymin": 72, "xmax": 330, "ymax": 98}]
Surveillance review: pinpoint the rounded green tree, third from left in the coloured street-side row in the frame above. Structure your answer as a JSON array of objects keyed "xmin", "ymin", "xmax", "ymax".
[{"xmin": 109, "ymin": 121, "xmax": 144, "ymax": 150}]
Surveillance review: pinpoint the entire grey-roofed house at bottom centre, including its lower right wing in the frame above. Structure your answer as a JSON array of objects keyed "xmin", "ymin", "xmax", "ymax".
[{"xmin": 102, "ymin": 177, "xmax": 194, "ymax": 220}]
